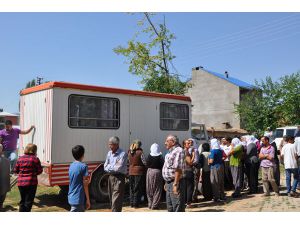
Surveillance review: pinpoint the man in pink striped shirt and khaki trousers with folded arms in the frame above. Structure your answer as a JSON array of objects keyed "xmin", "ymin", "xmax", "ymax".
[{"xmin": 259, "ymin": 136, "xmax": 279, "ymax": 196}]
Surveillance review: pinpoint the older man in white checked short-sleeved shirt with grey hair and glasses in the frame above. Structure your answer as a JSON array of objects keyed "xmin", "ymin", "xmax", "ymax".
[{"xmin": 162, "ymin": 135, "xmax": 185, "ymax": 212}]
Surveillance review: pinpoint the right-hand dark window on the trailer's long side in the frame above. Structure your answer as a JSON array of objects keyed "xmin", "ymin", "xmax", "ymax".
[{"xmin": 160, "ymin": 102, "xmax": 189, "ymax": 130}]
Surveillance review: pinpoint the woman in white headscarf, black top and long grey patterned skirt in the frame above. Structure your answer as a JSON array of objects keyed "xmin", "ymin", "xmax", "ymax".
[{"xmin": 146, "ymin": 143, "xmax": 164, "ymax": 209}]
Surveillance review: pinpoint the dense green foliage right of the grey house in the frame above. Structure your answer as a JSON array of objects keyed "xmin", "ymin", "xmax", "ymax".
[{"xmin": 235, "ymin": 72, "xmax": 300, "ymax": 134}]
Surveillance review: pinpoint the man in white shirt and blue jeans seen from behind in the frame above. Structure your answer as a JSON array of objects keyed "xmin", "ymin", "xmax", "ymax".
[{"xmin": 280, "ymin": 136, "xmax": 300, "ymax": 197}]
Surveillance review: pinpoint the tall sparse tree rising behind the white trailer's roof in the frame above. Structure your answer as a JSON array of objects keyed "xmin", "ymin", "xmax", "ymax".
[{"xmin": 114, "ymin": 13, "xmax": 190, "ymax": 95}]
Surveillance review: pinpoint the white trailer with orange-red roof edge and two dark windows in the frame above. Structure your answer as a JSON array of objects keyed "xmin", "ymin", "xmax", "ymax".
[{"xmin": 20, "ymin": 82, "xmax": 191, "ymax": 201}]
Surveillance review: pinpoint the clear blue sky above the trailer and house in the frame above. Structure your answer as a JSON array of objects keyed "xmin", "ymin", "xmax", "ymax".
[{"xmin": 0, "ymin": 13, "xmax": 300, "ymax": 112}]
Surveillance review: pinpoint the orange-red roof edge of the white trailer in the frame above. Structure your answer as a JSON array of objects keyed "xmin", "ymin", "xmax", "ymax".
[{"xmin": 20, "ymin": 81, "xmax": 191, "ymax": 102}]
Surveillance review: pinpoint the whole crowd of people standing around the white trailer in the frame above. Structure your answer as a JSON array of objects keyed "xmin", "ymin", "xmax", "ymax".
[{"xmin": 0, "ymin": 121, "xmax": 300, "ymax": 212}]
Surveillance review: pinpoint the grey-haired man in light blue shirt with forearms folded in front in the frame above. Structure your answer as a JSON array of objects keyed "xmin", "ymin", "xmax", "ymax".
[{"xmin": 104, "ymin": 137, "xmax": 128, "ymax": 212}]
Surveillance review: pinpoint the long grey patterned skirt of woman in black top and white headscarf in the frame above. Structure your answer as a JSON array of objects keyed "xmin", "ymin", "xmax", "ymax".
[{"xmin": 146, "ymin": 168, "xmax": 164, "ymax": 209}]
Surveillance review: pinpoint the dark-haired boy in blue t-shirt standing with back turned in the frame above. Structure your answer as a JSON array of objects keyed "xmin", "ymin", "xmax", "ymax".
[{"xmin": 68, "ymin": 145, "xmax": 91, "ymax": 212}]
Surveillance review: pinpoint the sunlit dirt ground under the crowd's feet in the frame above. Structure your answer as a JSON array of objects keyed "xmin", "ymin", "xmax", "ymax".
[{"xmin": 4, "ymin": 173, "xmax": 300, "ymax": 212}]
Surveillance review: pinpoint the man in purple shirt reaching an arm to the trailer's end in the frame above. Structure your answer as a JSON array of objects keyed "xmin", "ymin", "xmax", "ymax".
[{"xmin": 0, "ymin": 120, "xmax": 35, "ymax": 171}]
